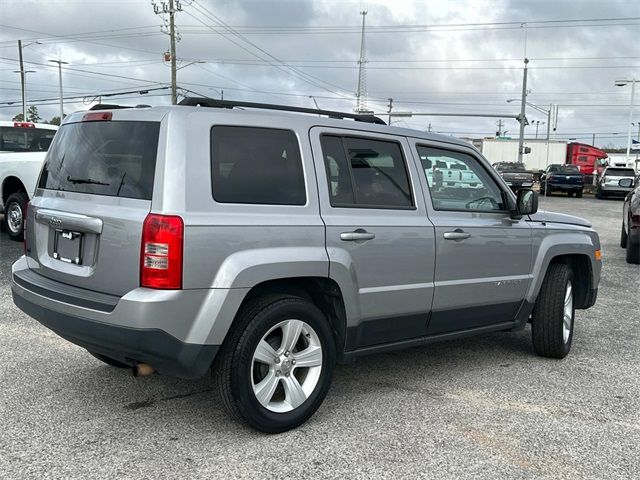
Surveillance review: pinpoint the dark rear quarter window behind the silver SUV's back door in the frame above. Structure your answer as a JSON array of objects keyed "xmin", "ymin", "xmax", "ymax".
[{"xmin": 211, "ymin": 126, "xmax": 306, "ymax": 205}]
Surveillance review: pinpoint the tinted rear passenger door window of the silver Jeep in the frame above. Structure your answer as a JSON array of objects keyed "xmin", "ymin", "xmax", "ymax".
[{"xmin": 321, "ymin": 135, "xmax": 413, "ymax": 208}]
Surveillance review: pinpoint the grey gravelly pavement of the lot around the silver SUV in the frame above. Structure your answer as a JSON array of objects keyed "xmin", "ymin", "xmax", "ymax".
[{"xmin": 0, "ymin": 196, "xmax": 640, "ymax": 479}]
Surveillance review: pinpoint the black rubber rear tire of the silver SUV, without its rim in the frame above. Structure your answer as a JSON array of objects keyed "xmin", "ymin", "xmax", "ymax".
[{"xmin": 213, "ymin": 295, "xmax": 336, "ymax": 433}]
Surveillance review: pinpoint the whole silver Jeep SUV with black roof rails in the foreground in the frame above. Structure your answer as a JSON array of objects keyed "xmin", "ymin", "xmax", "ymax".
[{"xmin": 12, "ymin": 99, "xmax": 601, "ymax": 432}]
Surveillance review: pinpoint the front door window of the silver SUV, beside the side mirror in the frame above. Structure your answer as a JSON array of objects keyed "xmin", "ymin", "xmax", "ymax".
[{"xmin": 418, "ymin": 146, "xmax": 504, "ymax": 212}]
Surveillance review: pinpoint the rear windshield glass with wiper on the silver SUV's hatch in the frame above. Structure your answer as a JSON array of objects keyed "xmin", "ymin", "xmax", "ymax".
[{"xmin": 38, "ymin": 121, "xmax": 160, "ymax": 200}]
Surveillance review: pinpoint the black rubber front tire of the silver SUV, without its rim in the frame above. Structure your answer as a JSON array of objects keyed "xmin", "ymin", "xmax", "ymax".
[{"xmin": 531, "ymin": 263, "xmax": 575, "ymax": 358}]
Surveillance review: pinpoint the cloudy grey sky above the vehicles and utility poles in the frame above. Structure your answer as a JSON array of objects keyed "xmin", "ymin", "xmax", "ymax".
[{"xmin": 0, "ymin": 0, "xmax": 640, "ymax": 146}]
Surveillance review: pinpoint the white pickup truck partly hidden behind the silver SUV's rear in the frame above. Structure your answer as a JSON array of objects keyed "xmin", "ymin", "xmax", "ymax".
[{"xmin": 0, "ymin": 121, "xmax": 58, "ymax": 241}]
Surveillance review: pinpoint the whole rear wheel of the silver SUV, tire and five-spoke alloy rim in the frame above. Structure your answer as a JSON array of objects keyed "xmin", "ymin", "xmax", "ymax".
[{"xmin": 214, "ymin": 296, "xmax": 336, "ymax": 433}]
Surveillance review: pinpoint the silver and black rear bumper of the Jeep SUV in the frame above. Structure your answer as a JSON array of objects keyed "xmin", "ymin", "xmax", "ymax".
[{"xmin": 11, "ymin": 257, "xmax": 242, "ymax": 378}]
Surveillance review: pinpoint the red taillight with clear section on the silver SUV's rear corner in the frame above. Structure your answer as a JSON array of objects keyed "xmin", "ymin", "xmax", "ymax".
[{"xmin": 140, "ymin": 213, "xmax": 184, "ymax": 290}]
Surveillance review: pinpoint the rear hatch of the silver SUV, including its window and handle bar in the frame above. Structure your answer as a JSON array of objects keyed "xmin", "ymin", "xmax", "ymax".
[{"xmin": 25, "ymin": 112, "xmax": 160, "ymax": 295}]
